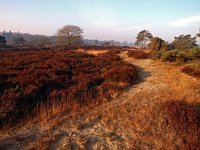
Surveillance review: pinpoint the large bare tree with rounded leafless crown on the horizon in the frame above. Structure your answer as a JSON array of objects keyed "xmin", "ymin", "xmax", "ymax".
[{"xmin": 56, "ymin": 25, "xmax": 83, "ymax": 46}]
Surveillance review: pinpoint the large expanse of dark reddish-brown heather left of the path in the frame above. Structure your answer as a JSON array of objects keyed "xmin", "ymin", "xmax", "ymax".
[{"xmin": 0, "ymin": 51, "xmax": 137, "ymax": 125}]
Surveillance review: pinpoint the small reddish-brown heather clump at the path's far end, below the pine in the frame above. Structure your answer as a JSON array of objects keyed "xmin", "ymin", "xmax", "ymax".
[{"xmin": 128, "ymin": 50, "xmax": 150, "ymax": 59}]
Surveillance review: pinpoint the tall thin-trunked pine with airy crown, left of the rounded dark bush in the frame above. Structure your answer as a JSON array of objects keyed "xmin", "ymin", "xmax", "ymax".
[{"xmin": 135, "ymin": 30, "xmax": 153, "ymax": 47}]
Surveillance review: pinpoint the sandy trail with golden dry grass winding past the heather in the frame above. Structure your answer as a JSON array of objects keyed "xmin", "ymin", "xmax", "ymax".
[{"xmin": 0, "ymin": 52, "xmax": 200, "ymax": 149}]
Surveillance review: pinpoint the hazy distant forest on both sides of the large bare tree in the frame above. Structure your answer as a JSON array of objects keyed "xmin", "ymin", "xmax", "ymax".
[{"xmin": 0, "ymin": 31, "xmax": 134, "ymax": 47}]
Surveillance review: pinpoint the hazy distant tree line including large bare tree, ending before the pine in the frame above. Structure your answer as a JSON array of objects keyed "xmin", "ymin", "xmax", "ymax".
[{"xmin": 0, "ymin": 25, "xmax": 134, "ymax": 48}]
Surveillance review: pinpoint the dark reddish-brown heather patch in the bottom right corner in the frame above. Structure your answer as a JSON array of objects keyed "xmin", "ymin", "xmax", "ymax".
[{"xmin": 163, "ymin": 101, "xmax": 200, "ymax": 149}]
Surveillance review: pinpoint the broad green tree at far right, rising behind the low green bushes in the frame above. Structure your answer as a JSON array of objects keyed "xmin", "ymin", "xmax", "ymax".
[{"xmin": 172, "ymin": 34, "xmax": 196, "ymax": 50}]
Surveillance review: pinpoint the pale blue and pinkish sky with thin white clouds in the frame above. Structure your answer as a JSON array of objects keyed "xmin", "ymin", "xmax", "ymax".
[{"xmin": 0, "ymin": 0, "xmax": 200, "ymax": 42}]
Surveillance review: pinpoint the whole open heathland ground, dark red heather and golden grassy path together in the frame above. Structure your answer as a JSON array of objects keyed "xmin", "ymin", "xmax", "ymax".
[{"xmin": 0, "ymin": 49, "xmax": 200, "ymax": 150}]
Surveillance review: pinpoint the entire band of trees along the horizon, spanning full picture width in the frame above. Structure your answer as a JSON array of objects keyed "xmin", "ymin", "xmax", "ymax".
[{"xmin": 0, "ymin": 25, "xmax": 200, "ymax": 50}]
